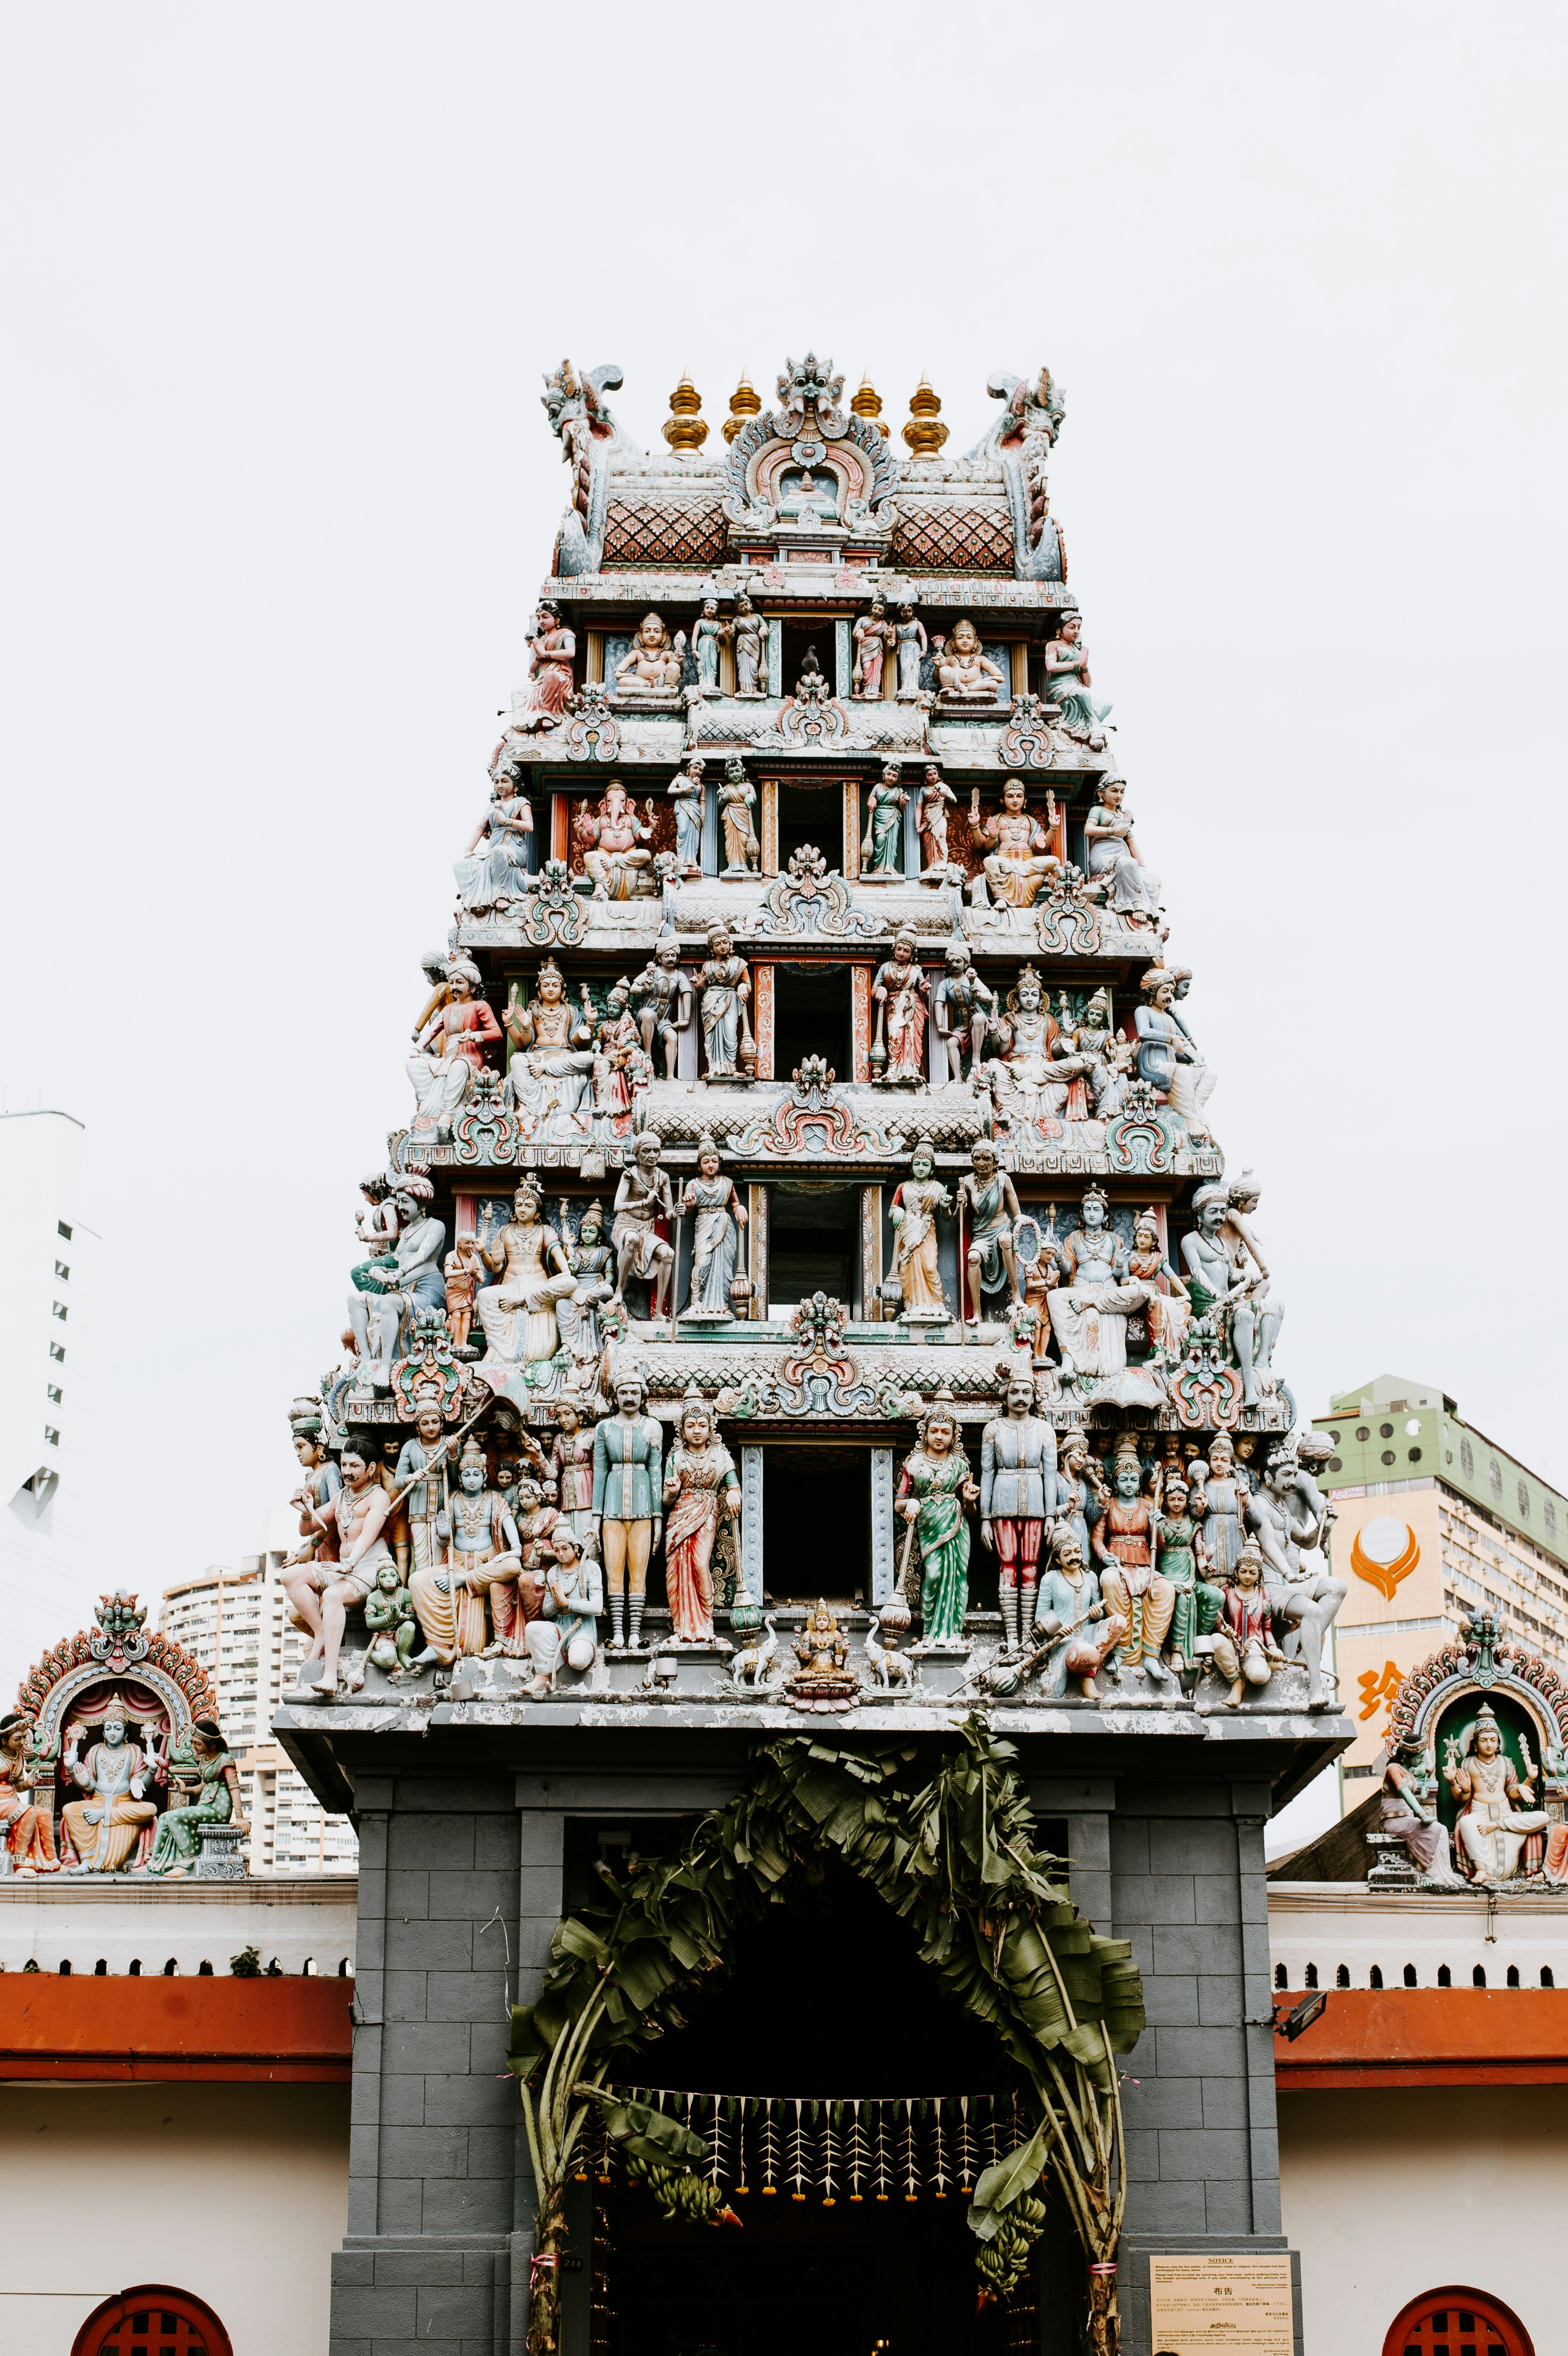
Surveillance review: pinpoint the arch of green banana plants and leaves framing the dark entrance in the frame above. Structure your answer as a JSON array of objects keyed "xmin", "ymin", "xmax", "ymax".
[{"xmin": 508, "ymin": 1718, "xmax": 1144, "ymax": 2356}]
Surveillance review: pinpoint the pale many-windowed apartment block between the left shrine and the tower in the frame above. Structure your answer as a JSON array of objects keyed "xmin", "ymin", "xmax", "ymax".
[{"xmin": 158, "ymin": 1550, "xmax": 358, "ymax": 1873}]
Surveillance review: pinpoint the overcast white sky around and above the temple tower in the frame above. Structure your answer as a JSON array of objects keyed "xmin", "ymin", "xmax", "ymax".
[{"xmin": 0, "ymin": 0, "xmax": 1568, "ymax": 1691}]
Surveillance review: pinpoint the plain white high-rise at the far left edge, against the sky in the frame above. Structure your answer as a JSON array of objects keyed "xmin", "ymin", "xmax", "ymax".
[{"xmin": 0, "ymin": 1112, "xmax": 100, "ymax": 1659}]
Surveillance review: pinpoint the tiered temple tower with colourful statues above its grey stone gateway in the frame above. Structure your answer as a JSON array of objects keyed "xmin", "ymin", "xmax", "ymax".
[{"xmin": 287, "ymin": 356, "xmax": 1352, "ymax": 2356}]
